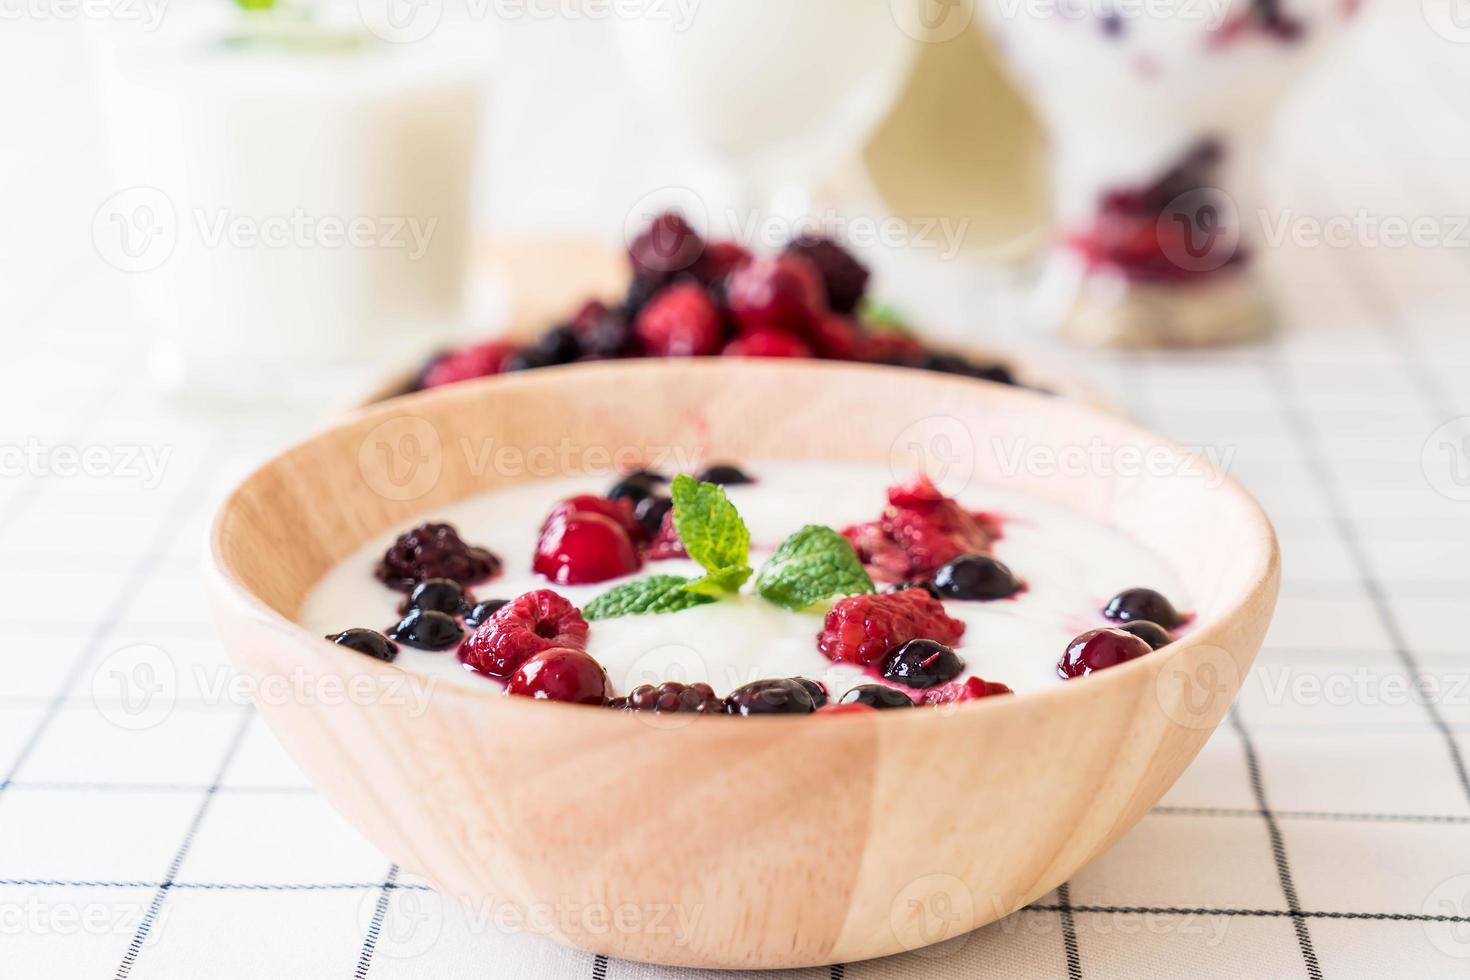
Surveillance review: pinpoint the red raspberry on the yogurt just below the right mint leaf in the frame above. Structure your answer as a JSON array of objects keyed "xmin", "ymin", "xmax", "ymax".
[{"xmin": 817, "ymin": 589, "xmax": 964, "ymax": 667}]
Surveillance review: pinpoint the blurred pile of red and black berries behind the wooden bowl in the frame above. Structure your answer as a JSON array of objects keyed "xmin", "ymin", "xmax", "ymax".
[{"xmin": 415, "ymin": 212, "xmax": 1017, "ymax": 389}]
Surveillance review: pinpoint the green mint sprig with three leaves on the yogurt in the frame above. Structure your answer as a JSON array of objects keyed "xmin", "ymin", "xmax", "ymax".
[{"xmin": 582, "ymin": 475, "xmax": 873, "ymax": 620}]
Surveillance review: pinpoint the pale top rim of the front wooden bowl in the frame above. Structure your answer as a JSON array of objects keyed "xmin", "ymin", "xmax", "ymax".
[{"xmin": 206, "ymin": 357, "xmax": 1280, "ymax": 726}]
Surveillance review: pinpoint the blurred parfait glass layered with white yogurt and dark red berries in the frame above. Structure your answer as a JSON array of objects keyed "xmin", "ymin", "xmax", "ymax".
[{"xmin": 985, "ymin": 0, "xmax": 1358, "ymax": 347}]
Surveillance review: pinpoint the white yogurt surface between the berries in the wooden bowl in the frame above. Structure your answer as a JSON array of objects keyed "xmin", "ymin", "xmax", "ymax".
[{"xmin": 300, "ymin": 461, "xmax": 1191, "ymax": 696}]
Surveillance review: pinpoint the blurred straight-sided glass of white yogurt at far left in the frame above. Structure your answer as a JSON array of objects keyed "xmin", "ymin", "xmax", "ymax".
[{"xmin": 93, "ymin": 3, "xmax": 482, "ymax": 401}]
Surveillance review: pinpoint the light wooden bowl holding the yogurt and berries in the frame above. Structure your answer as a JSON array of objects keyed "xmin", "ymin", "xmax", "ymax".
[{"xmin": 210, "ymin": 361, "xmax": 1279, "ymax": 968}]
